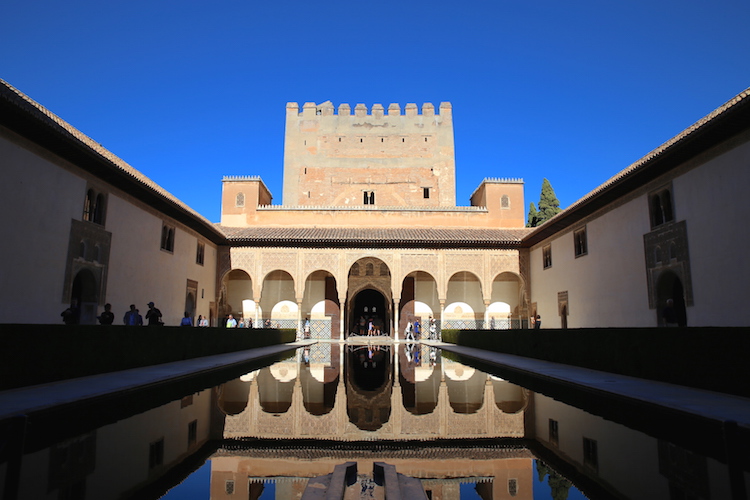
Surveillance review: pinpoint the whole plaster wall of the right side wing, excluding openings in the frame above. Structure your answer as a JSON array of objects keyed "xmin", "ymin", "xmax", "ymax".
[{"xmin": 530, "ymin": 135, "xmax": 750, "ymax": 328}]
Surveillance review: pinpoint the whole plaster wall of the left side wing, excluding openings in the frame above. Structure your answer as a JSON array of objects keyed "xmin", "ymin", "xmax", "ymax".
[{"xmin": 0, "ymin": 128, "xmax": 217, "ymax": 325}]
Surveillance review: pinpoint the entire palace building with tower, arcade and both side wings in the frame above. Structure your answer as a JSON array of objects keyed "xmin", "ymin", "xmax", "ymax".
[{"xmin": 0, "ymin": 81, "xmax": 750, "ymax": 330}]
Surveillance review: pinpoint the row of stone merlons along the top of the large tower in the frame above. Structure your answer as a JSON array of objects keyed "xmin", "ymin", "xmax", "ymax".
[{"xmin": 286, "ymin": 101, "xmax": 453, "ymax": 118}]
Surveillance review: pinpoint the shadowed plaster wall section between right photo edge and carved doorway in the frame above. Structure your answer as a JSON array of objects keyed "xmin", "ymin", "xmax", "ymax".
[{"xmin": 672, "ymin": 142, "xmax": 750, "ymax": 326}]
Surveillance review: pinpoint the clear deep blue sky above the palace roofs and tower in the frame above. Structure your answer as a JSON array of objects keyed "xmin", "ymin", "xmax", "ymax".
[{"xmin": 0, "ymin": 0, "xmax": 750, "ymax": 222}]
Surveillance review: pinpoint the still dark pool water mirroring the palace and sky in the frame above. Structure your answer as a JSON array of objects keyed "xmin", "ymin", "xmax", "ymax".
[{"xmin": 0, "ymin": 343, "xmax": 747, "ymax": 500}]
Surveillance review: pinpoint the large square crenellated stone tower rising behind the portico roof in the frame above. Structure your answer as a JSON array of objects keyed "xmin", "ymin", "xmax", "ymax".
[{"xmin": 283, "ymin": 101, "xmax": 456, "ymax": 208}]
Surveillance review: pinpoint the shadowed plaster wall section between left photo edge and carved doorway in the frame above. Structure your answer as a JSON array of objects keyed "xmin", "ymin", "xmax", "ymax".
[{"xmin": 0, "ymin": 129, "xmax": 86, "ymax": 324}]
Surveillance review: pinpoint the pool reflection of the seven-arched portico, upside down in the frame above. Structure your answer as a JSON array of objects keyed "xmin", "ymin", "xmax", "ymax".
[{"xmin": 220, "ymin": 344, "xmax": 529, "ymax": 441}]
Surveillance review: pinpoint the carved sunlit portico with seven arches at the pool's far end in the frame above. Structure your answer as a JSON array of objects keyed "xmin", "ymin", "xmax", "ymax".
[{"xmin": 220, "ymin": 230, "xmax": 528, "ymax": 339}]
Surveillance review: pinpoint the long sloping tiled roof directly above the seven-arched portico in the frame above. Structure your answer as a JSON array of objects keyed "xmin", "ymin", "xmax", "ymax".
[{"xmin": 218, "ymin": 226, "xmax": 531, "ymax": 248}]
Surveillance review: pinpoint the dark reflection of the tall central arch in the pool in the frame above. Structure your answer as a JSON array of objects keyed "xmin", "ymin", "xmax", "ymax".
[{"xmin": 346, "ymin": 345, "xmax": 393, "ymax": 431}]
